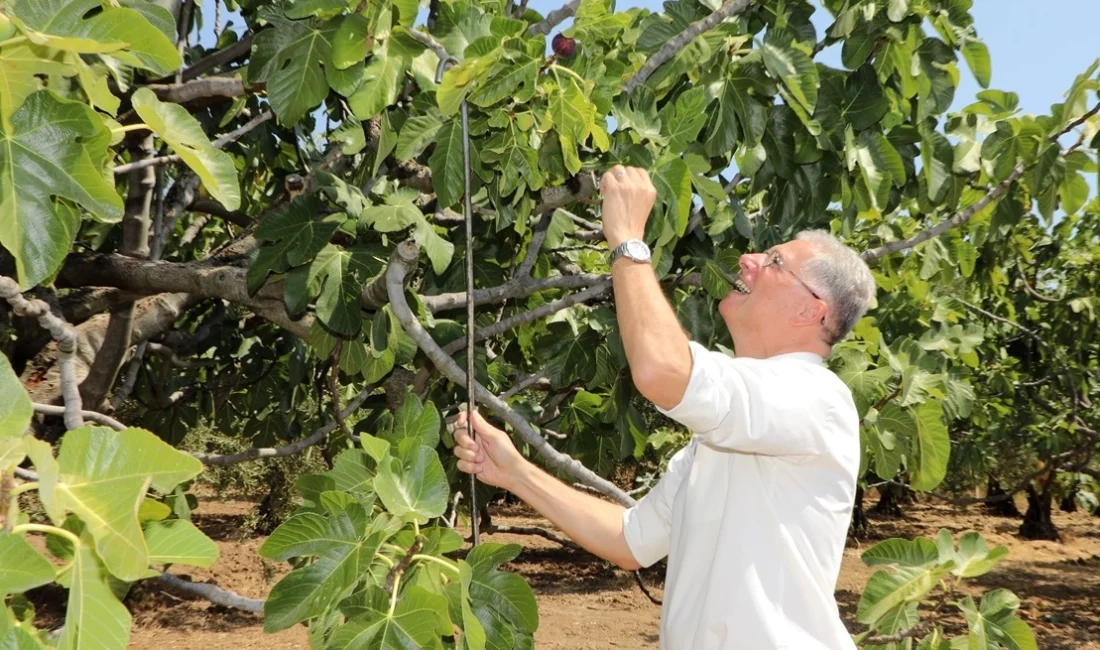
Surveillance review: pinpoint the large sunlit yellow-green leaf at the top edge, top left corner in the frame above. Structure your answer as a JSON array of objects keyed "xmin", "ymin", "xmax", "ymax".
[{"xmin": 11, "ymin": 0, "xmax": 183, "ymax": 75}]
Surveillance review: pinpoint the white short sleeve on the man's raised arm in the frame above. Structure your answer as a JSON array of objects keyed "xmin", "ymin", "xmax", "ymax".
[{"xmin": 658, "ymin": 341, "xmax": 827, "ymax": 456}]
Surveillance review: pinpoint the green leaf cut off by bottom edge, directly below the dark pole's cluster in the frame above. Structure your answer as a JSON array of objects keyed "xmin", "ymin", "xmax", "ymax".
[{"xmin": 326, "ymin": 585, "xmax": 451, "ymax": 650}]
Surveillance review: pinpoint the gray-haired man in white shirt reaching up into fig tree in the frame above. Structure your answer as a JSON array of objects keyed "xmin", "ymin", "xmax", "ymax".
[{"xmin": 454, "ymin": 166, "xmax": 875, "ymax": 650}]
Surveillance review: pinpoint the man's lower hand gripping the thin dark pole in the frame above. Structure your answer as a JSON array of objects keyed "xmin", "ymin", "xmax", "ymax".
[{"xmin": 454, "ymin": 411, "xmax": 528, "ymax": 489}]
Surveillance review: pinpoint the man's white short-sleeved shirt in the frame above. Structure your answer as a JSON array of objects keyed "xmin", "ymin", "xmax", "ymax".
[{"xmin": 623, "ymin": 342, "xmax": 859, "ymax": 650}]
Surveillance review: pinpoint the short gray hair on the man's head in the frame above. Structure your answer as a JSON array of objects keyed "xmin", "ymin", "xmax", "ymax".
[{"xmin": 795, "ymin": 230, "xmax": 877, "ymax": 345}]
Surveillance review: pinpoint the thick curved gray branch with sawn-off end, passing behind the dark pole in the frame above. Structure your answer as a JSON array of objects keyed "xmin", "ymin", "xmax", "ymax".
[{"xmin": 386, "ymin": 241, "xmax": 635, "ymax": 506}]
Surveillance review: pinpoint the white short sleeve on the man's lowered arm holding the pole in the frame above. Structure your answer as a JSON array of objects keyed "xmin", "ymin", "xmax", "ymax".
[{"xmin": 623, "ymin": 440, "xmax": 695, "ymax": 566}]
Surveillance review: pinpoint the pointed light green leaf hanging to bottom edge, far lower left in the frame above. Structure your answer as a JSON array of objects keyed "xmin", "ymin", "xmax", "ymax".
[{"xmin": 57, "ymin": 543, "xmax": 130, "ymax": 650}]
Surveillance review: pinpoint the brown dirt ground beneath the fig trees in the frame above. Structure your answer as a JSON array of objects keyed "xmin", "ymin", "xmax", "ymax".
[{"xmin": 23, "ymin": 500, "xmax": 1100, "ymax": 650}]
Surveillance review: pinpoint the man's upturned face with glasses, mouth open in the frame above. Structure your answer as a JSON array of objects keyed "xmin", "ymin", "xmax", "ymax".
[{"xmin": 718, "ymin": 240, "xmax": 823, "ymax": 342}]
